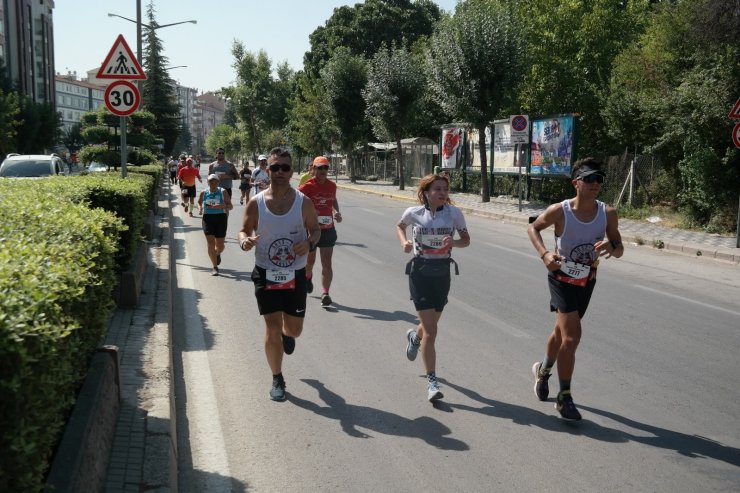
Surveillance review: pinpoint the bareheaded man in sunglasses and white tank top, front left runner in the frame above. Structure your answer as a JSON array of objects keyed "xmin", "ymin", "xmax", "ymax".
[{"xmin": 239, "ymin": 147, "xmax": 321, "ymax": 401}]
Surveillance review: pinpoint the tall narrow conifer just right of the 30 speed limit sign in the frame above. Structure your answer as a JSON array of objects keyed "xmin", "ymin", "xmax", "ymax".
[{"xmin": 141, "ymin": 3, "xmax": 180, "ymax": 155}]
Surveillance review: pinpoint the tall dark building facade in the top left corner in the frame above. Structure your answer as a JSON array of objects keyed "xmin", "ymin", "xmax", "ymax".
[{"xmin": 0, "ymin": 0, "xmax": 56, "ymax": 103}]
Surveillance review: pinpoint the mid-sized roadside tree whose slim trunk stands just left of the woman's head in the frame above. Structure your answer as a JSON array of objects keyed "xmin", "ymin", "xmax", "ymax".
[{"xmin": 362, "ymin": 47, "xmax": 425, "ymax": 190}]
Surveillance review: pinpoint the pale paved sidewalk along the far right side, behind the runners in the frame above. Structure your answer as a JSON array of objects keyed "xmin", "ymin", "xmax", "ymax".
[{"xmin": 337, "ymin": 176, "xmax": 740, "ymax": 264}]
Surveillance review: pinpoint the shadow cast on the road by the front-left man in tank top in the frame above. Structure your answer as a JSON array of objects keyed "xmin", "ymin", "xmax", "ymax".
[{"xmin": 288, "ymin": 379, "xmax": 470, "ymax": 451}]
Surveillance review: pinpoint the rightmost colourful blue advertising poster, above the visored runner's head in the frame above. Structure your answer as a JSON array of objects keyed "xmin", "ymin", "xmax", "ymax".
[{"xmin": 531, "ymin": 115, "xmax": 575, "ymax": 176}]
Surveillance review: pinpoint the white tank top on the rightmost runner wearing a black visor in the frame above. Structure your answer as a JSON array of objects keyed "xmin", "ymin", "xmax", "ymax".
[{"xmin": 555, "ymin": 199, "xmax": 606, "ymax": 265}]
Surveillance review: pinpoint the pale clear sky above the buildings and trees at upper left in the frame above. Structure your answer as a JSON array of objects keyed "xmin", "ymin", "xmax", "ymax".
[{"xmin": 52, "ymin": 0, "xmax": 457, "ymax": 94}]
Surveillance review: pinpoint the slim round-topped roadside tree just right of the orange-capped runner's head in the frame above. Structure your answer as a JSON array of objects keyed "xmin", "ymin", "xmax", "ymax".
[{"xmin": 321, "ymin": 50, "xmax": 370, "ymax": 182}]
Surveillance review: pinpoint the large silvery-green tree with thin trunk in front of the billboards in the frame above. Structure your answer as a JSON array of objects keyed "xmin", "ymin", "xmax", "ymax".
[{"xmin": 427, "ymin": 0, "xmax": 524, "ymax": 202}]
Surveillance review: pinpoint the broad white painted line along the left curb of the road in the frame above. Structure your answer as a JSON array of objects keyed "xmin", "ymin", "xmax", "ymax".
[{"xmin": 175, "ymin": 229, "xmax": 231, "ymax": 491}]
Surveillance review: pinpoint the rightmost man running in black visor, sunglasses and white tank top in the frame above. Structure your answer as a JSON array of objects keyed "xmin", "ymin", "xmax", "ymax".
[{"xmin": 527, "ymin": 157, "xmax": 624, "ymax": 421}]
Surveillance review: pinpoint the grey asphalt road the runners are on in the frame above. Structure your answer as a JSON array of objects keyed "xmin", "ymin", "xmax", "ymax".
[{"xmin": 173, "ymin": 184, "xmax": 740, "ymax": 493}]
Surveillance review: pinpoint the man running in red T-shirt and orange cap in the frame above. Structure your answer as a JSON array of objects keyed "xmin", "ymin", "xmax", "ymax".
[{"xmin": 298, "ymin": 156, "xmax": 342, "ymax": 308}]
